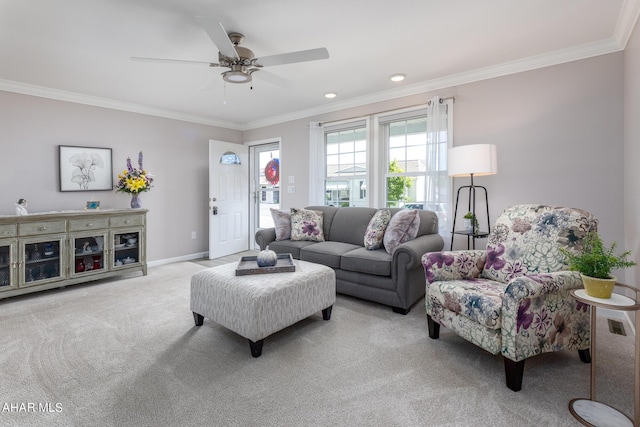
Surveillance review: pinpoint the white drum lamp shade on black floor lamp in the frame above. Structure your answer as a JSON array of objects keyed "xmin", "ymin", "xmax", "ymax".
[{"xmin": 447, "ymin": 144, "xmax": 498, "ymax": 176}]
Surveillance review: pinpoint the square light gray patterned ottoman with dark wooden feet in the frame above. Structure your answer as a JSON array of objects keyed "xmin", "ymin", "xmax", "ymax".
[{"xmin": 191, "ymin": 260, "xmax": 336, "ymax": 357}]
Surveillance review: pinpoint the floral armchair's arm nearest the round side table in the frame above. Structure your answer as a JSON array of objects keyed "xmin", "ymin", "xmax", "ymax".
[{"xmin": 502, "ymin": 271, "xmax": 590, "ymax": 362}]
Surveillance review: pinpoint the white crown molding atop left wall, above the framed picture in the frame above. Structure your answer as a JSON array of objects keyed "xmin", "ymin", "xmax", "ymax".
[{"xmin": 0, "ymin": 79, "xmax": 243, "ymax": 130}]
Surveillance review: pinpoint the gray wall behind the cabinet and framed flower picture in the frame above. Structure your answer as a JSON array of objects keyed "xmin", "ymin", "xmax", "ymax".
[{"xmin": 0, "ymin": 91, "xmax": 242, "ymax": 261}]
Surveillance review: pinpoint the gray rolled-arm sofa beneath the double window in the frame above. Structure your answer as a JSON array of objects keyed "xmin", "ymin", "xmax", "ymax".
[{"xmin": 255, "ymin": 206, "xmax": 444, "ymax": 314}]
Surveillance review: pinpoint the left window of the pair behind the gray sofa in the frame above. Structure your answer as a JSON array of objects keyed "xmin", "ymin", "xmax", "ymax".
[{"xmin": 324, "ymin": 121, "xmax": 368, "ymax": 207}]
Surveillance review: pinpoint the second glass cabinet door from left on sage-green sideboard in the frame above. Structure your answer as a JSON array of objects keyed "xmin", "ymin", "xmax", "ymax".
[{"xmin": 20, "ymin": 236, "xmax": 65, "ymax": 286}]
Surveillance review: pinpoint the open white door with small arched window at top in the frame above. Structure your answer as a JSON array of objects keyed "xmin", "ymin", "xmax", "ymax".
[{"xmin": 209, "ymin": 140, "xmax": 249, "ymax": 259}]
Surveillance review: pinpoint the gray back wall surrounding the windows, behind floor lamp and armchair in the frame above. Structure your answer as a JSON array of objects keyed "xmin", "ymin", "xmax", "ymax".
[{"xmin": 244, "ymin": 53, "xmax": 624, "ymax": 248}]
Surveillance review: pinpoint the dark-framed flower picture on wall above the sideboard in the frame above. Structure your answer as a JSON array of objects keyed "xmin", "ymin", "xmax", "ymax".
[{"xmin": 58, "ymin": 145, "xmax": 113, "ymax": 192}]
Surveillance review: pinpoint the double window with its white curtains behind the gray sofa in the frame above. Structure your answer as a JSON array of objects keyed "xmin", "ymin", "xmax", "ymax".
[{"xmin": 309, "ymin": 97, "xmax": 453, "ymax": 240}]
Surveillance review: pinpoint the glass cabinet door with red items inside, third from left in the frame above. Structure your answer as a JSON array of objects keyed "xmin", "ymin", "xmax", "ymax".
[{"xmin": 69, "ymin": 231, "xmax": 109, "ymax": 276}]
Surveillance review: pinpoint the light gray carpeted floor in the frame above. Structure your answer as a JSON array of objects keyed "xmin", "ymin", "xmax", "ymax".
[{"xmin": 0, "ymin": 261, "xmax": 634, "ymax": 427}]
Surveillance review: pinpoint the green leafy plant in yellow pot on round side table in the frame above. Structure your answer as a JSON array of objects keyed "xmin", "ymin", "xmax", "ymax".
[{"xmin": 560, "ymin": 232, "xmax": 636, "ymax": 298}]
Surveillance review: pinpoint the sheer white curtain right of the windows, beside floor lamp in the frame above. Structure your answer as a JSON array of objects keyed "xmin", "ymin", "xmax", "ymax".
[{"xmin": 426, "ymin": 96, "xmax": 453, "ymax": 242}]
